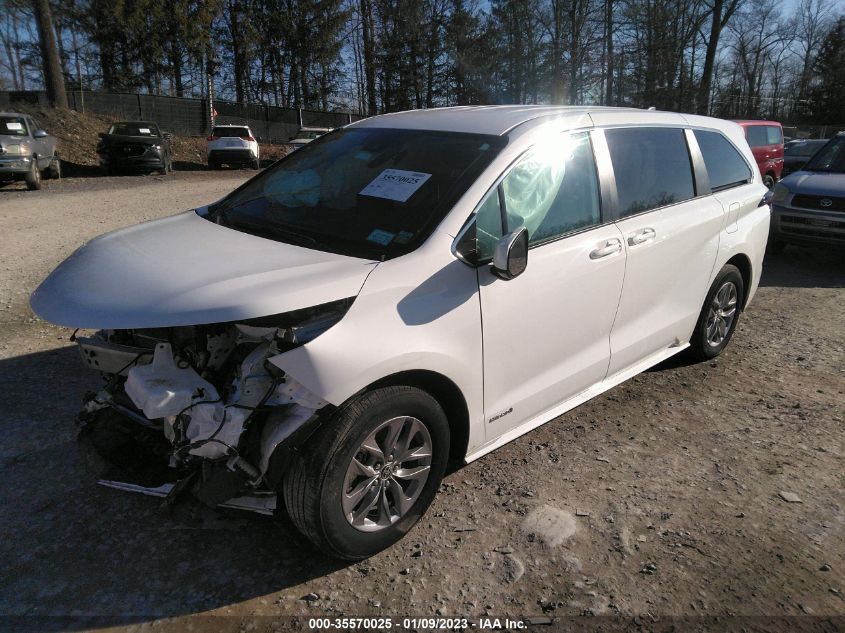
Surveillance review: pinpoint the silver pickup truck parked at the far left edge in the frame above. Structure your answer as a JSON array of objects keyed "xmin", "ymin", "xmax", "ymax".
[{"xmin": 0, "ymin": 112, "xmax": 62, "ymax": 190}]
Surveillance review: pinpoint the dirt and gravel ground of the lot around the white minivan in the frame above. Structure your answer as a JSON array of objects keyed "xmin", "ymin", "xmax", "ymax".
[{"xmin": 0, "ymin": 171, "xmax": 845, "ymax": 631}]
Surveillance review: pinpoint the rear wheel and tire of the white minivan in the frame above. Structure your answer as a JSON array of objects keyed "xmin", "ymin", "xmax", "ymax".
[{"xmin": 690, "ymin": 264, "xmax": 745, "ymax": 361}]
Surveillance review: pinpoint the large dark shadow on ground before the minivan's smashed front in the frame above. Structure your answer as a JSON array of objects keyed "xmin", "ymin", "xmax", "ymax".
[{"xmin": 0, "ymin": 346, "xmax": 346, "ymax": 631}]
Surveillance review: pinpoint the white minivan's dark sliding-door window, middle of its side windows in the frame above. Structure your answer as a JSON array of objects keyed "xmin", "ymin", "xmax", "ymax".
[{"xmin": 605, "ymin": 128, "xmax": 695, "ymax": 217}]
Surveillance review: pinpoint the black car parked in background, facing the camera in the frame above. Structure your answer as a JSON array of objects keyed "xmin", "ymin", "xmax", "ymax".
[{"xmin": 97, "ymin": 121, "xmax": 173, "ymax": 175}]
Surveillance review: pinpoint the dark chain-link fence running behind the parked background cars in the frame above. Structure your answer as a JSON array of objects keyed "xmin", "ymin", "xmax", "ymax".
[{"xmin": 0, "ymin": 90, "xmax": 362, "ymax": 143}]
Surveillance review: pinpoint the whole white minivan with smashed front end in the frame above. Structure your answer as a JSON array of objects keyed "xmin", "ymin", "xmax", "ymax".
[{"xmin": 31, "ymin": 106, "xmax": 770, "ymax": 559}]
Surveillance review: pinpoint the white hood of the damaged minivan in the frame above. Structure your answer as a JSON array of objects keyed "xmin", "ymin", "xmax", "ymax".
[{"xmin": 30, "ymin": 211, "xmax": 377, "ymax": 329}]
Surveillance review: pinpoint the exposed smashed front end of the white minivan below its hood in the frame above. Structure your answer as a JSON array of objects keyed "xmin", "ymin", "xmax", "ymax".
[{"xmin": 76, "ymin": 299, "xmax": 352, "ymax": 513}]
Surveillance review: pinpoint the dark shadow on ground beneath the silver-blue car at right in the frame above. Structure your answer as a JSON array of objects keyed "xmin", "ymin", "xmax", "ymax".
[{"xmin": 760, "ymin": 245, "xmax": 845, "ymax": 288}]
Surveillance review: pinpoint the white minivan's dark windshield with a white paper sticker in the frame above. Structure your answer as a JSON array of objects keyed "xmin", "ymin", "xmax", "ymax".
[{"xmin": 209, "ymin": 127, "xmax": 506, "ymax": 259}]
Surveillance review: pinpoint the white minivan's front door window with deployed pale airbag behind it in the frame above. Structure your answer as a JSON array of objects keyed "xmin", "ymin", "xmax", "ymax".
[{"xmin": 501, "ymin": 133, "xmax": 601, "ymax": 244}]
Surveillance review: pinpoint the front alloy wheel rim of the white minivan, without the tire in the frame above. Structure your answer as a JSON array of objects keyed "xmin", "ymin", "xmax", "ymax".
[{"xmin": 341, "ymin": 416, "xmax": 432, "ymax": 532}]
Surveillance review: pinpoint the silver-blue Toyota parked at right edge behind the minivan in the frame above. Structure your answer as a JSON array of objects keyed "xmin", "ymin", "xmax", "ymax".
[{"xmin": 769, "ymin": 132, "xmax": 845, "ymax": 252}]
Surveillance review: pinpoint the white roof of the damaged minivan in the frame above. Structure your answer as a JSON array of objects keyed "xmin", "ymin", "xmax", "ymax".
[{"xmin": 347, "ymin": 105, "xmax": 708, "ymax": 136}]
